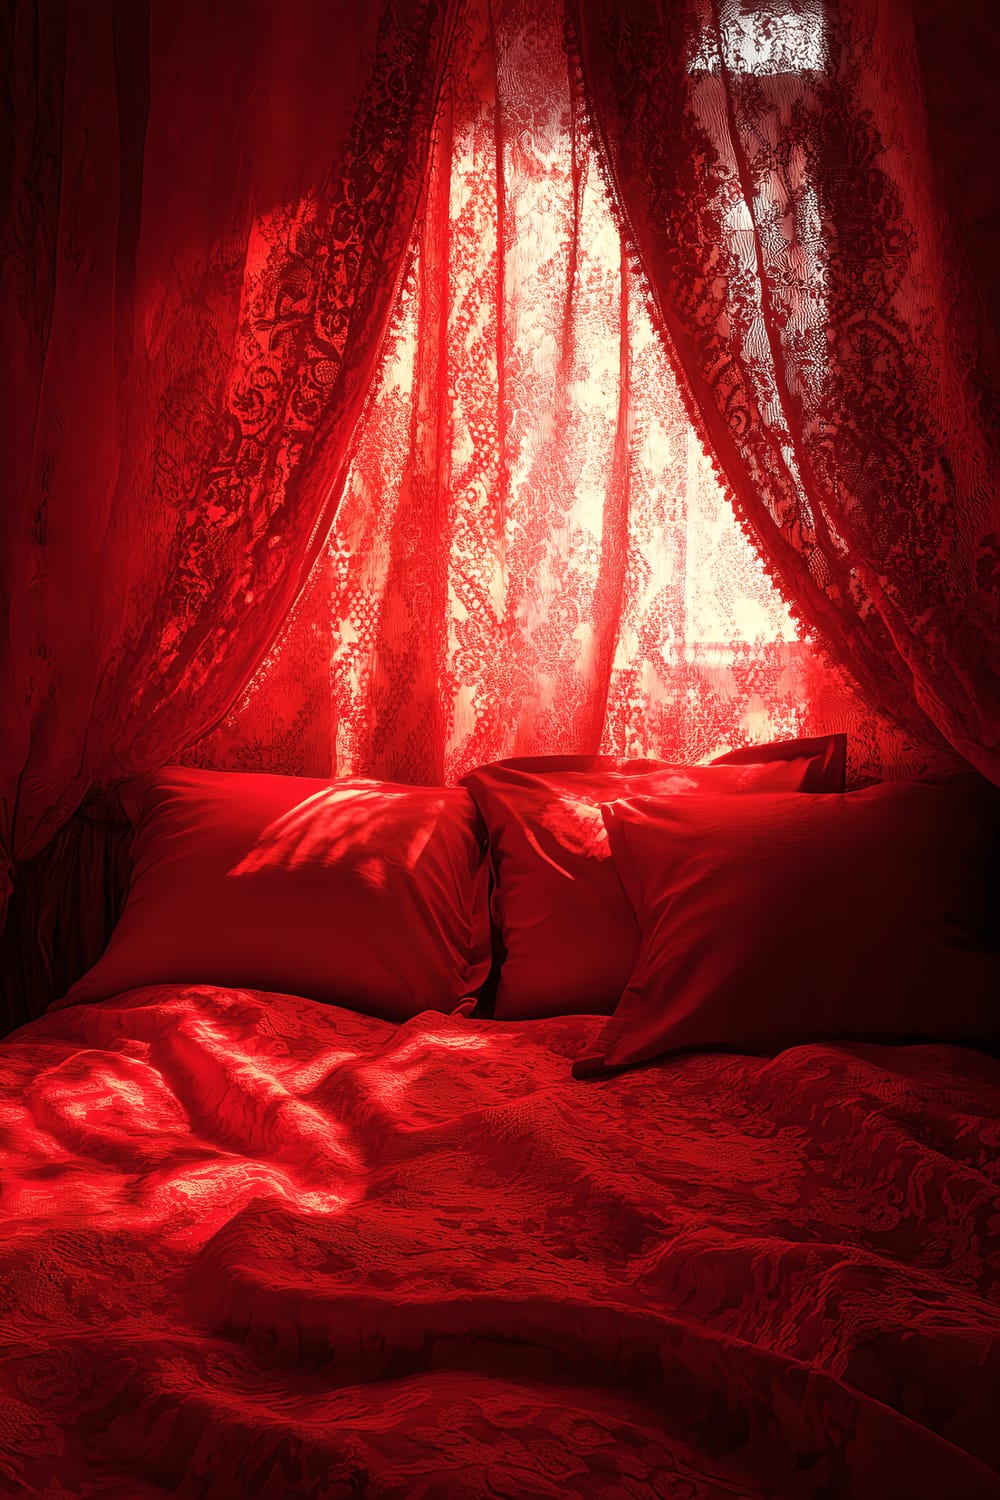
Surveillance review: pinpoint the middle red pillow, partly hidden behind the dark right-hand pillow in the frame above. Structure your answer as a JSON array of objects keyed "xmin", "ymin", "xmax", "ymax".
[{"xmin": 463, "ymin": 735, "xmax": 844, "ymax": 1020}]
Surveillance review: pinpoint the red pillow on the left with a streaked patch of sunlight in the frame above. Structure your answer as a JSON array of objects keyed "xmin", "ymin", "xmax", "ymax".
[{"xmin": 61, "ymin": 767, "xmax": 490, "ymax": 1020}]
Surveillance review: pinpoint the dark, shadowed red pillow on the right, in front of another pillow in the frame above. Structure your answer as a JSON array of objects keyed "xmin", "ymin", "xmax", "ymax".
[{"xmin": 573, "ymin": 783, "xmax": 1000, "ymax": 1077}]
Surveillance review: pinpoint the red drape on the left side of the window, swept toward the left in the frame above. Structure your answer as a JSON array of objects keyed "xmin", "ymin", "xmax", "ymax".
[{"xmin": 0, "ymin": 0, "xmax": 451, "ymax": 960}]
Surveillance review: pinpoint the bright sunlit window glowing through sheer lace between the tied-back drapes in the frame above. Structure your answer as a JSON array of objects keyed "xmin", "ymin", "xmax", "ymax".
[{"xmin": 211, "ymin": 0, "xmax": 845, "ymax": 782}]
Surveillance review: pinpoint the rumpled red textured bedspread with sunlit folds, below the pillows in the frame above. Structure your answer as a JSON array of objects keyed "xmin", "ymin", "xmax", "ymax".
[{"xmin": 0, "ymin": 987, "xmax": 1000, "ymax": 1500}]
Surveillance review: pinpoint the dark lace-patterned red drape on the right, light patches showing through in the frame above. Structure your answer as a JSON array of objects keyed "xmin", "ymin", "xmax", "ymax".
[{"xmin": 570, "ymin": 0, "xmax": 1000, "ymax": 780}]
